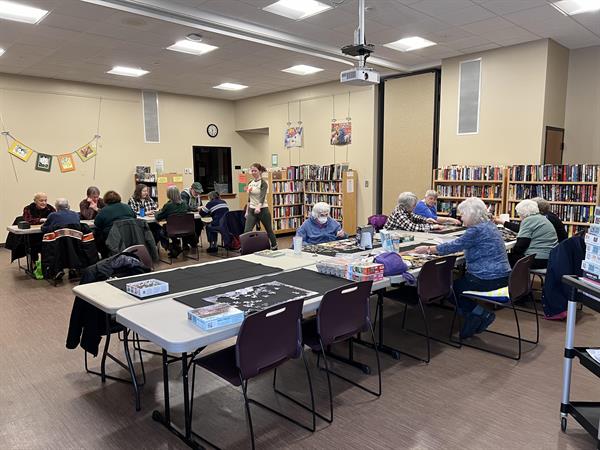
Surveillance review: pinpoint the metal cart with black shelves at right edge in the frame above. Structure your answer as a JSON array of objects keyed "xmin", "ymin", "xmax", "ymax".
[{"xmin": 560, "ymin": 275, "xmax": 600, "ymax": 450}]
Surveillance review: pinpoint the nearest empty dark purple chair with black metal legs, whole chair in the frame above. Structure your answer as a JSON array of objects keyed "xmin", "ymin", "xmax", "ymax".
[{"xmin": 190, "ymin": 300, "xmax": 316, "ymax": 449}]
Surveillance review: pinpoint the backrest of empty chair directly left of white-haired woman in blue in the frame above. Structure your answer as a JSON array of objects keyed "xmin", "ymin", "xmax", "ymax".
[{"xmin": 417, "ymin": 255, "xmax": 456, "ymax": 303}]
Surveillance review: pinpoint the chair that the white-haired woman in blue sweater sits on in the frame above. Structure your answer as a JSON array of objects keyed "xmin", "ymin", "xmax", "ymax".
[{"xmin": 450, "ymin": 255, "xmax": 540, "ymax": 361}]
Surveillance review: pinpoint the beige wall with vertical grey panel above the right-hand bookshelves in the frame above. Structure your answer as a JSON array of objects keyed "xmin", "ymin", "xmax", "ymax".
[{"xmin": 439, "ymin": 40, "xmax": 548, "ymax": 165}]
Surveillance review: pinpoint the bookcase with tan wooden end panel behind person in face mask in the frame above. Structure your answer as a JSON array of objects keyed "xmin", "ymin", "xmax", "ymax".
[{"xmin": 300, "ymin": 164, "xmax": 358, "ymax": 234}]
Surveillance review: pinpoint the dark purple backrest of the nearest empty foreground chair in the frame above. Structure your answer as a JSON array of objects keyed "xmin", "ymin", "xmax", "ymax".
[{"xmin": 235, "ymin": 300, "xmax": 303, "ymax": 380}]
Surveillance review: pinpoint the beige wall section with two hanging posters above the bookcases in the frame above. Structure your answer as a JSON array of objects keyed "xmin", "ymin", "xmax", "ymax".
[{"xmin": 235, "ymin": 82, "xmax": 376, "ymax": 223}]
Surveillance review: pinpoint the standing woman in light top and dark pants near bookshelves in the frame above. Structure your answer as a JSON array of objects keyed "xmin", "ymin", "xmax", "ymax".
[{"xmin": 244, "ymin": 163, "xmax": 277, "ymax": 250}]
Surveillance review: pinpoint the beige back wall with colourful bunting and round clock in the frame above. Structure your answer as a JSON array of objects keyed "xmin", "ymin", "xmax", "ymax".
[{"xmin": 0, "ymin": 75, "xmax": 248, "ymax": 242}]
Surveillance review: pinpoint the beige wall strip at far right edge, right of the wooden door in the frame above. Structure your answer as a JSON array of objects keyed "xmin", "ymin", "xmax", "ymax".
[{"xmin": 563, "ymin": 46, "xmax": 600, "ymax": 164}]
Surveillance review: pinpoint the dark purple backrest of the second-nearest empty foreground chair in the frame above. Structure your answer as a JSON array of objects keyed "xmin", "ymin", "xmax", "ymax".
[{"xmin": 317, "ymin": 281, "xmax": 373, "ymax": 346}]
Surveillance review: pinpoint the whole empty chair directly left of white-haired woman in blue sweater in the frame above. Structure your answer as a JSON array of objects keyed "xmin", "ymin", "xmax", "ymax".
[{"xmin": 378, "ymin": 255, "xmax": 457, "ymax": 363}]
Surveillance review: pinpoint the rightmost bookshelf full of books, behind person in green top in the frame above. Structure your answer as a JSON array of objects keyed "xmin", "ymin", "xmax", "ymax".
[{"xmin": 506, "ymin": 164, "xmax": 600, "ymax": 236}]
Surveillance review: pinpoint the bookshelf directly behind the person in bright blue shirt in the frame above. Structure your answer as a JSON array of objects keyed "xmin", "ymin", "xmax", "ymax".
[{"xmin": 433, "ymin": 166, "xmax": 506, "ymax": 215}]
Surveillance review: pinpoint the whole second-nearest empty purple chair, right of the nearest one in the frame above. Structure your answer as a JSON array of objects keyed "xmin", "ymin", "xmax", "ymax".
[{"xmin": 296, "ymin": 281, "xmax": 381, "ymax": 423}]
